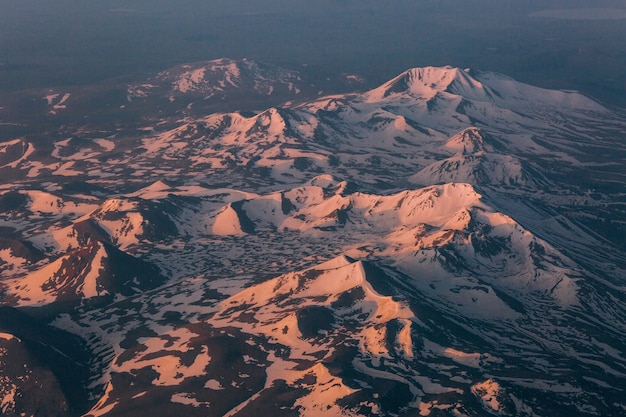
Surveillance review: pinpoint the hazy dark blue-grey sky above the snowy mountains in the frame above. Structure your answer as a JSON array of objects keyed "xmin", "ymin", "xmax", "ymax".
[{"xmin": 0, "ymin": 0, "xmax": 626, "ymax": 105}]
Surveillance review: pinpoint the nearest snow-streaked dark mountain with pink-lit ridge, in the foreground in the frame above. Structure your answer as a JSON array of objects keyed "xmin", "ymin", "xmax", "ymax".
[{"xmin": 58, "ymin": 252, "xmax": 626, "ymax": 416}]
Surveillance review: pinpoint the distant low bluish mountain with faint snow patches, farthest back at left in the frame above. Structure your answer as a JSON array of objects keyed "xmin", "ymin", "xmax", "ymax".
[{"xmin": 0, "ymin": 58, "xmax": 366, "ymax": 136}]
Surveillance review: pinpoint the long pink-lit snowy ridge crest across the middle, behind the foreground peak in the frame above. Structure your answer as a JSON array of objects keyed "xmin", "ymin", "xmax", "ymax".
[{"xmin": 207, "ymin": 182, "xmax": 488, "ymax": 236}]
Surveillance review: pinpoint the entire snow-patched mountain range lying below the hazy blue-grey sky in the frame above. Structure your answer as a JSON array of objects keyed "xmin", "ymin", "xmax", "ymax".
[{"xmin": 0, "ymin": 59, "xmax": 626, "ymax": 417}]
